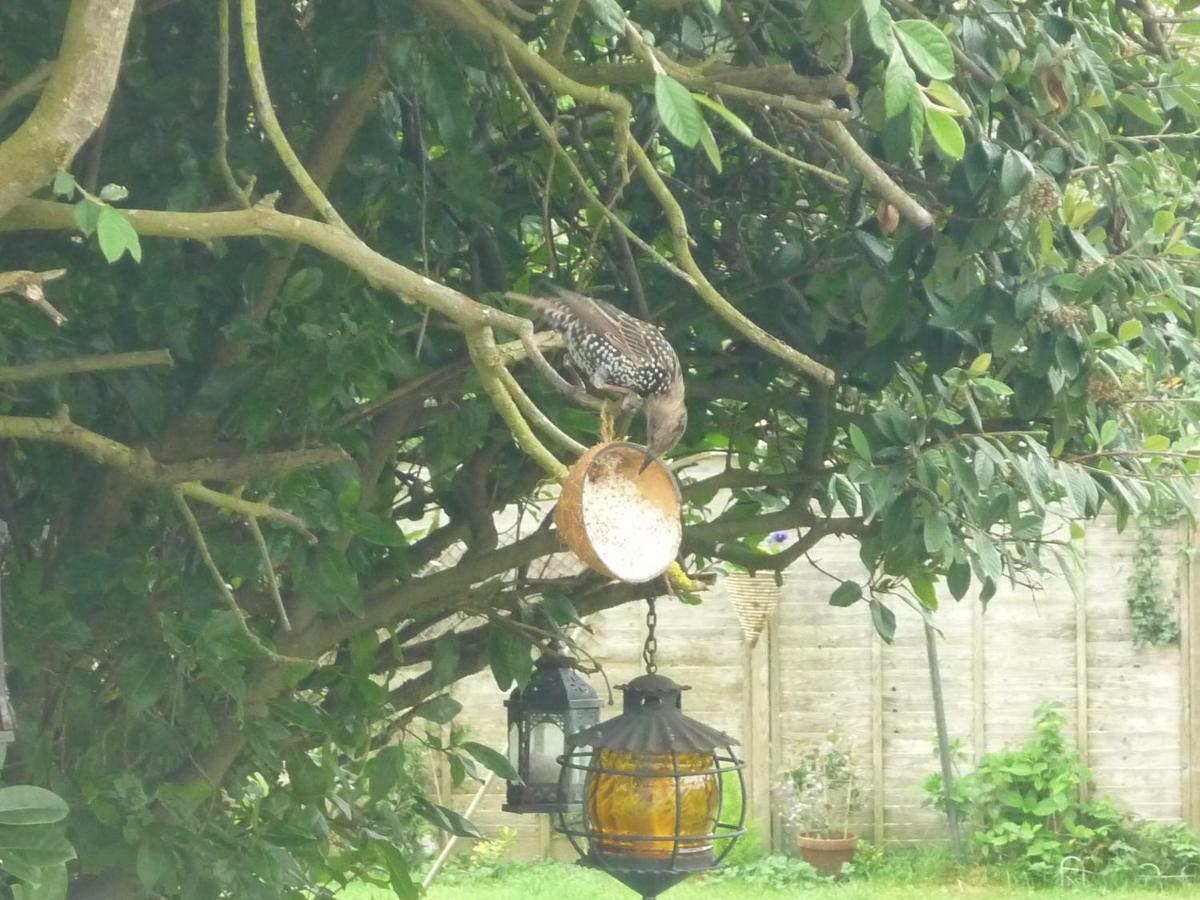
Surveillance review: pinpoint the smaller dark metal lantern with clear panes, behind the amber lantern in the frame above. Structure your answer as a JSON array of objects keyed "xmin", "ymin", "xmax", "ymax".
[{"xmin": 504, "ymin": 646, "xmax": 600, "ymax": 812}]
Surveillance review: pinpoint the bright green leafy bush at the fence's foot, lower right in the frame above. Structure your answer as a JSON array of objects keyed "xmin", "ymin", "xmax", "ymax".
[{"xmin": 925, "ymin": 703, "xmax": 1200, "ymax": 882}]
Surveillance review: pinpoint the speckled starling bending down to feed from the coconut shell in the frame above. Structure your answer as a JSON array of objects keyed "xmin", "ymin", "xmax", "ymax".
[{"xmin": 510, "ymin": 287, "xmax": 688, "ymax": 470}]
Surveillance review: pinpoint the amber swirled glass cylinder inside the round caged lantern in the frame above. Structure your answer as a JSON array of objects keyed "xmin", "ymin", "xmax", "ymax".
[{"xmin": 587, "ymin": 750, "xmax": 720, "ymax": 859}]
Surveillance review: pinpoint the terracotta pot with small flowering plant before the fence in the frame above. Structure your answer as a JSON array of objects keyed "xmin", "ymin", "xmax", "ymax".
[{"xmin": 773, "ymin": 728, "xmax": 866, "ymax": 875}]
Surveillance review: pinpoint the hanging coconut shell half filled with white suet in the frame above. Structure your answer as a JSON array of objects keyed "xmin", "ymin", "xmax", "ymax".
[{"xmin": 554, "ymin": 440, "xmax": 683, "ymax": 584}]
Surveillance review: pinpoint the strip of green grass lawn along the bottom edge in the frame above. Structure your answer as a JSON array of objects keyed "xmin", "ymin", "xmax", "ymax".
[{"xmin": 340, "ymin": 864, "xmax": 1195, "ymax": 900}]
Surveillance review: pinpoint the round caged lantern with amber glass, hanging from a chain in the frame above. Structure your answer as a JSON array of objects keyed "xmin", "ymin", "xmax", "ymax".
[{"xmin": 556, "ymin": 604, "xmax": 745, "ymax": 898}]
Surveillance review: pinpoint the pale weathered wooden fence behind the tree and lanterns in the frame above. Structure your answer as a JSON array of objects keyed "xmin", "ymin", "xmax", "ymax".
[{"xmin": 450, "ymin": 520, "xmax": 1200, "ymax": 856}]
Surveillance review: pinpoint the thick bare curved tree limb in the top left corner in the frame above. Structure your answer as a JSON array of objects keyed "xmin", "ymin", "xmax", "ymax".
[{"xmin": 0, "ymin": 0, "xmax": 136, "ymax": 216}]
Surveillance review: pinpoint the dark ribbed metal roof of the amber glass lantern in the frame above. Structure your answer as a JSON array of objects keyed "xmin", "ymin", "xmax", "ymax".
[{"xmin": 566, "ymin": 673, "xmax": 738, "ymax": 754}]
